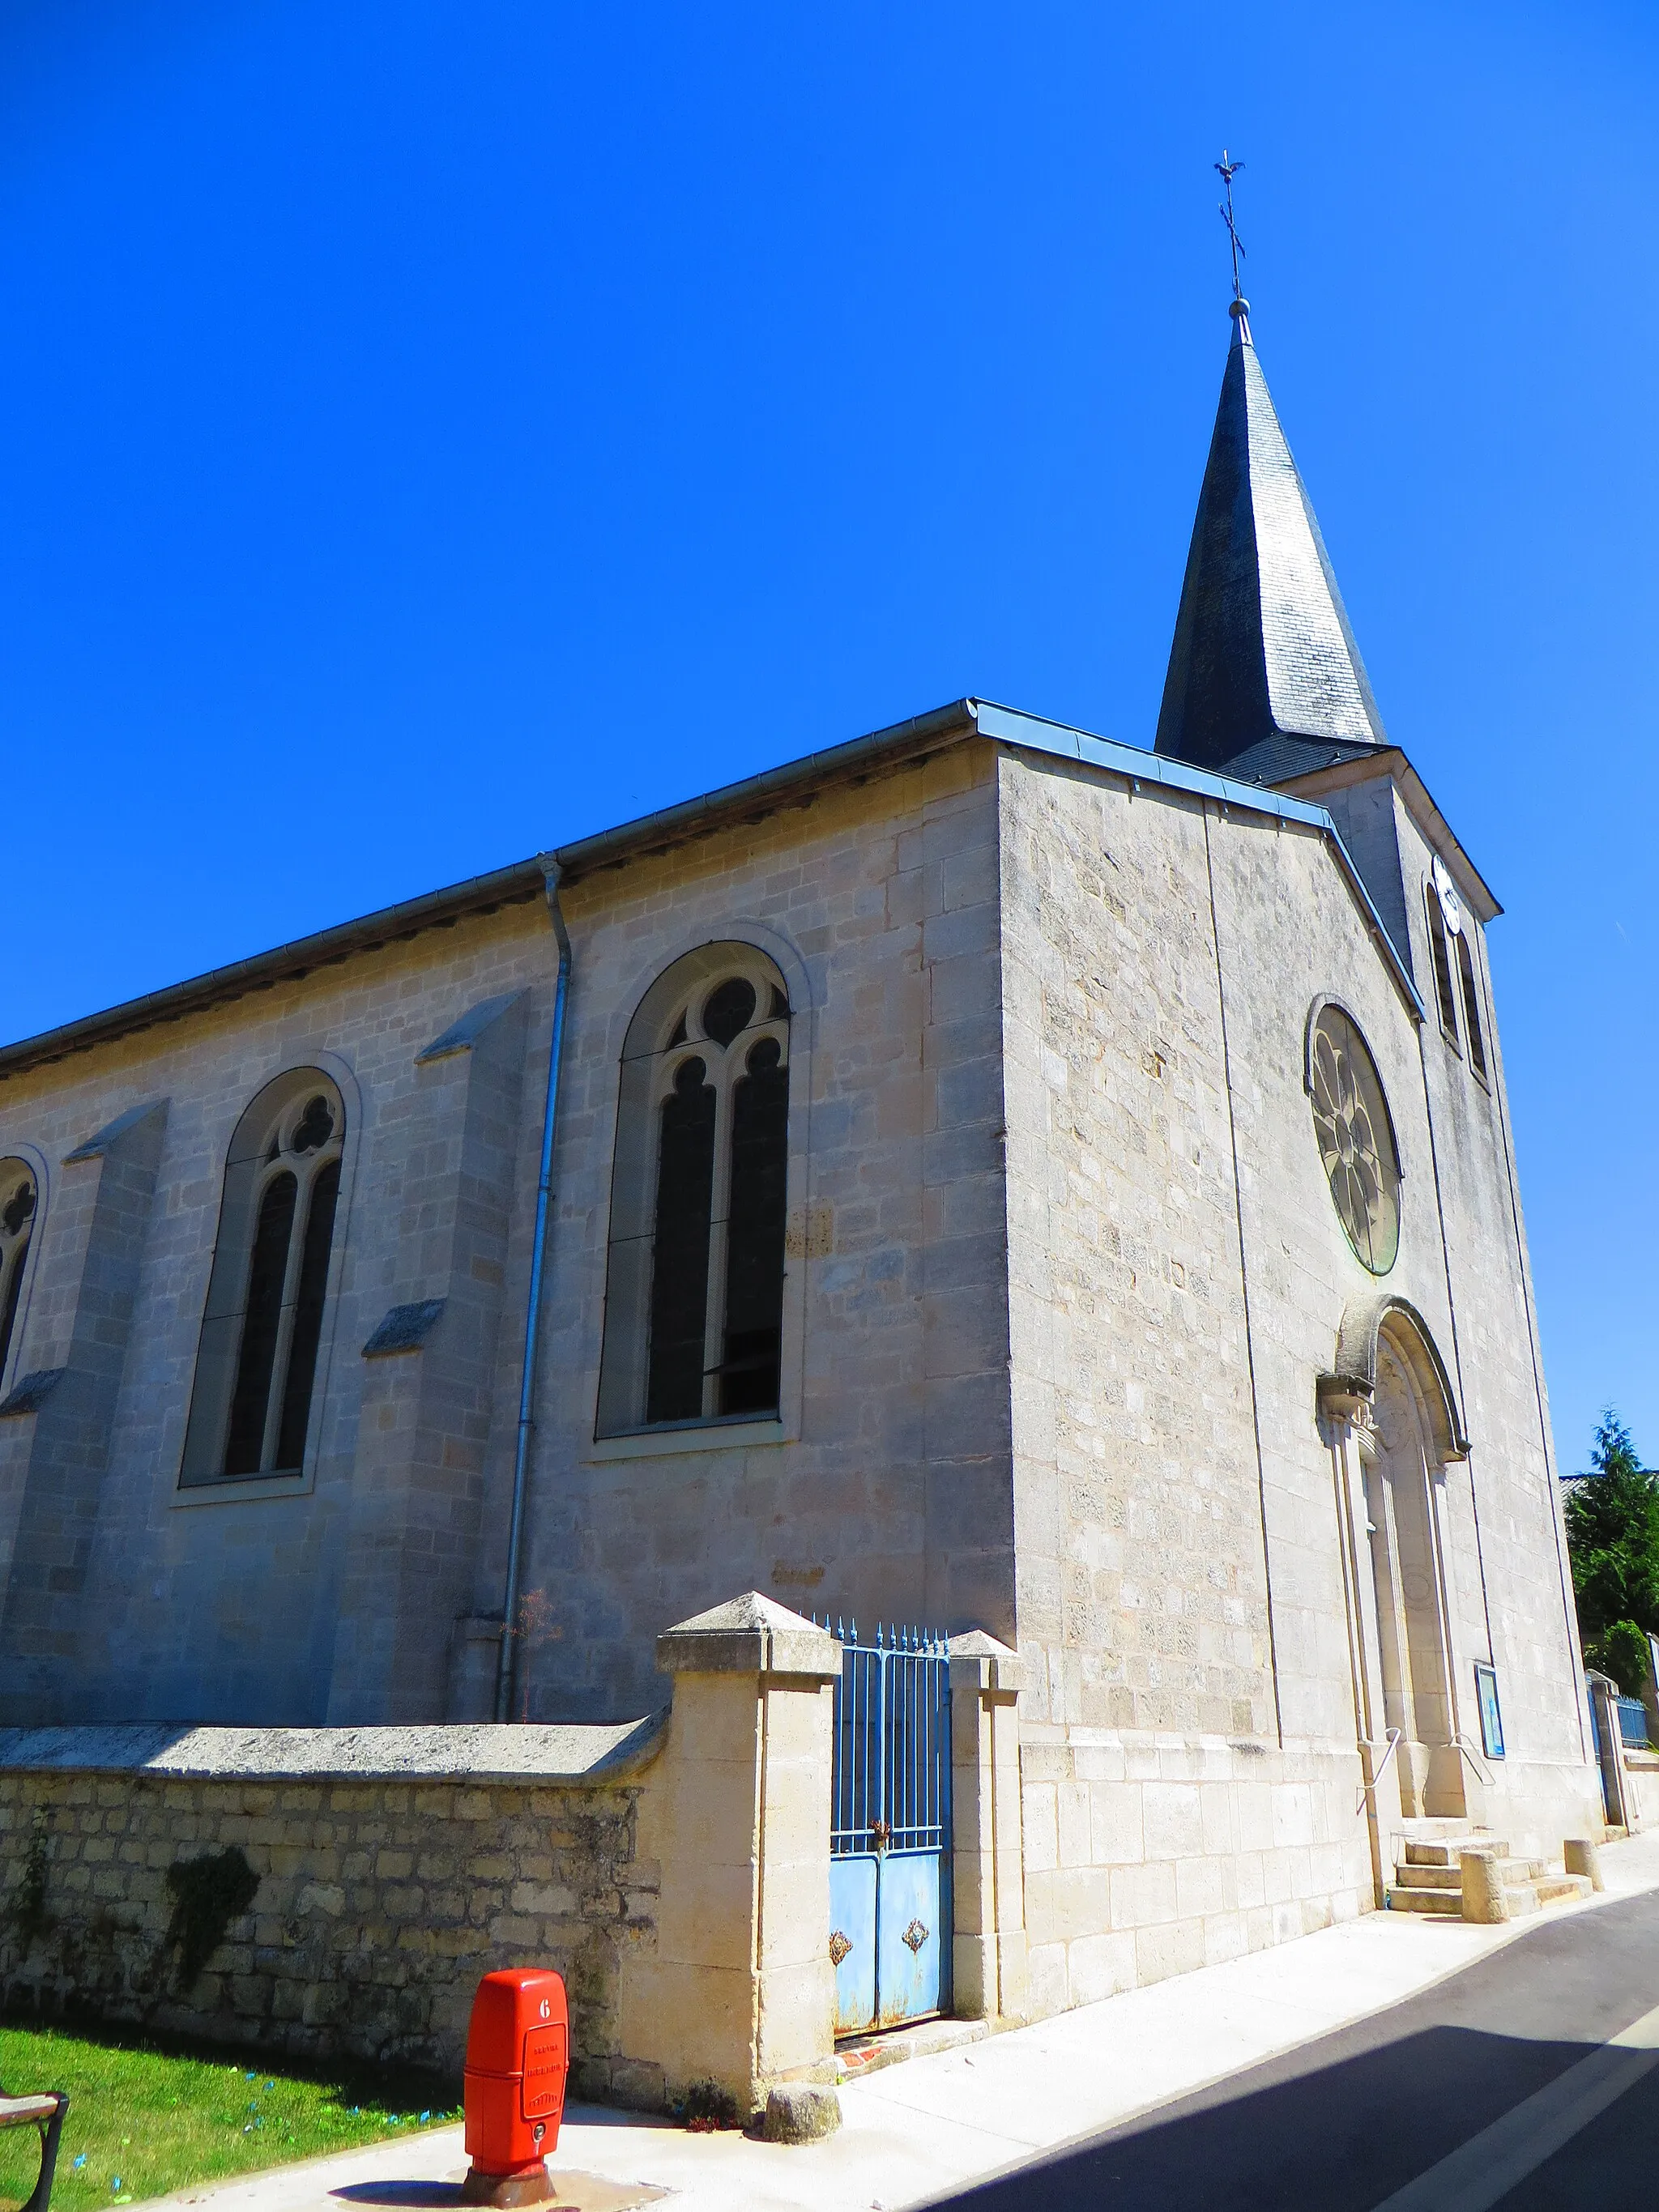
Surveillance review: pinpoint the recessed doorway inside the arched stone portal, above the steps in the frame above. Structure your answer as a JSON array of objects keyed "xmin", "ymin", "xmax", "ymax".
[{"xmin": 1365, "ymin": 1334, "xmax": 1469, "ymax": 1816}]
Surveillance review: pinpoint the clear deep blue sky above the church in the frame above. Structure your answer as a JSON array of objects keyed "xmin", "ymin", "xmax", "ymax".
[{"xmin": 0, "ymin": 0, "xmax": 1659, "ymax": 1467}]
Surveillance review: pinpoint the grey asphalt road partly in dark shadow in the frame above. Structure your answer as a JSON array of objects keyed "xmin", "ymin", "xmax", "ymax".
[{"xmin": 940, "ymin": 1894, "xmax": 1659, "ymax": 2212}]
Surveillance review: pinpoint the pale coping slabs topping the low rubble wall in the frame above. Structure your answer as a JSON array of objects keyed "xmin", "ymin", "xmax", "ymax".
[{"xmin": 0, "ymin": 1712, "xmax": 666, "ymax": 1783}]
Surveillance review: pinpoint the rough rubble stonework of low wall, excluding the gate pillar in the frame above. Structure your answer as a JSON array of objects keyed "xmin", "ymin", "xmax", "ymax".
[{"xmin": 0, "ymin": 1723, "xmax": 663, "ymax": 2106}]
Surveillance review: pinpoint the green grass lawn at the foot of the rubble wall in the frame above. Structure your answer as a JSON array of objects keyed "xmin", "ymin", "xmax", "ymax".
[{"xmin": 0, "ymin": 2024, "xmax": 460, "ymax": 2212}]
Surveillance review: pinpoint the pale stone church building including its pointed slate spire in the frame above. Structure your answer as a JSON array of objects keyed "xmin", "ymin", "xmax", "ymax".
[{"xmin": 0, "ymin": 314, "xmax": 1597, "ymax": 2010}]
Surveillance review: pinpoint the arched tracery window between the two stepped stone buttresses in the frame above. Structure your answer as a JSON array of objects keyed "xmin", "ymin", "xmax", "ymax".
[{"xmin": 179, "ymin": 1068, "xmax": 345, "ymax": 1486}]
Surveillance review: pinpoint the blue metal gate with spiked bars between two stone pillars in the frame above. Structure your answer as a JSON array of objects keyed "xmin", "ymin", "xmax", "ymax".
[{"xmin": 823, "ymin": 1622, "xmax": 951, "ymax": 2035}]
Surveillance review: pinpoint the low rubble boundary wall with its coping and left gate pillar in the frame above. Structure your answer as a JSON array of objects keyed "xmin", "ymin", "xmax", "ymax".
[{"xmin": 0, "ymin": 1591, "xmax": 858, "ymax": 2115}]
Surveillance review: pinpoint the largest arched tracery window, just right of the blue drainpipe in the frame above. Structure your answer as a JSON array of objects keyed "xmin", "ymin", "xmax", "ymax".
[{"xmin": 597, "ymin": 944, "xmax": 790, "ymax": 1435}]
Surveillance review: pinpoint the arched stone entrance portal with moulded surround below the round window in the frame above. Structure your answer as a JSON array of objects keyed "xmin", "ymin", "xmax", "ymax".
[{"xmin": 1323, "ymin": 1298, "xmax": 1471, "ymax": 1816}]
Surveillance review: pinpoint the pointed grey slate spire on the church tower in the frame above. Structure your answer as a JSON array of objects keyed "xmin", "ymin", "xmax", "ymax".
[{"xmin": 1157, "ymin": 299, "xmax": 1387, "ymax": 783}]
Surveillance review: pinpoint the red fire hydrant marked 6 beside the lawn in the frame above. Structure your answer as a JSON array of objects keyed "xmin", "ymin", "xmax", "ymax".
[{"xmin": 463, "ymin": 1967, "xmax": 571, "ymax": 2206}]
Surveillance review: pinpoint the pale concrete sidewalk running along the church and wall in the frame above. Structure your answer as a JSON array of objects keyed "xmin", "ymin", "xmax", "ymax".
[{"xmin": 146, "ymin": 1831, "xmax": 1659, "ymax": 2212}]
